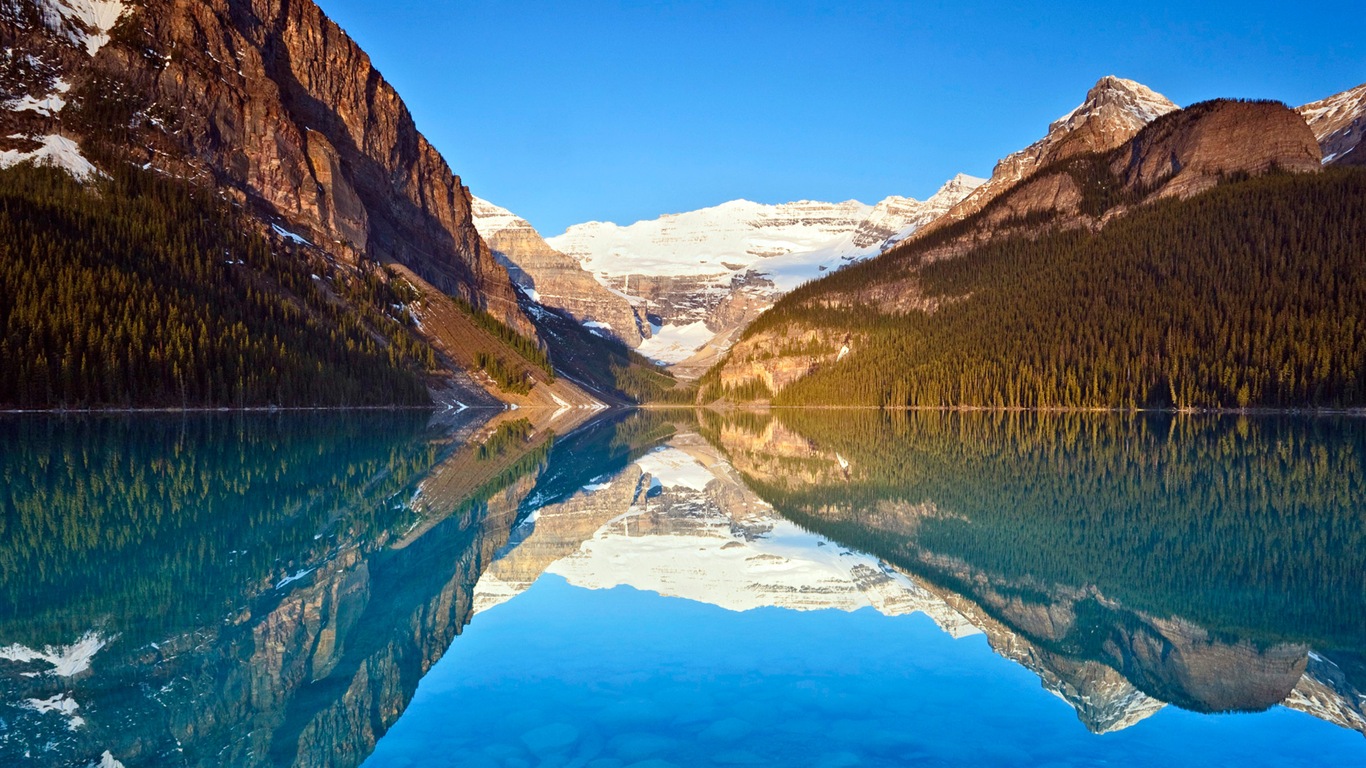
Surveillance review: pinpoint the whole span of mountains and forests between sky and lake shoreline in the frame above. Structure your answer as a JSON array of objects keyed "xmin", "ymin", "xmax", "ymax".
[{"xmin": 0, "ymin": 0, "xmax": 1366, "ymax": 410}]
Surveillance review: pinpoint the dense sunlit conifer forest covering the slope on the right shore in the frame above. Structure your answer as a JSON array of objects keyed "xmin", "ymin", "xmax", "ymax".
[{"xmin": 747, "ymin": 169, "xmax": 1366, "ymax": 407}]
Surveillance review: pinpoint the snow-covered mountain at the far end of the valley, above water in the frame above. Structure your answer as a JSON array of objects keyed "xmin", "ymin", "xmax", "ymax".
[{"xmin": 475, "ymin": 175, "xmax": 981, "ymax": 376}]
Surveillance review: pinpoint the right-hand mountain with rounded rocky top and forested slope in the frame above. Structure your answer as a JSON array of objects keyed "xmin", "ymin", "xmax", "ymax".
[{"xmin": 703, "ymin": 95, "xmax": 1366, "ymax": 407}]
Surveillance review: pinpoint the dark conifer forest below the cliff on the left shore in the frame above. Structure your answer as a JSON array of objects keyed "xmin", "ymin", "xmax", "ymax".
[{"xmin": 0, "ymin": 164, "xmax": 434, "ymax": 409}]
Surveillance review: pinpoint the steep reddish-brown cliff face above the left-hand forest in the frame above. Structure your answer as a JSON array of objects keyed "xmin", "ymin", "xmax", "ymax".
[{"xmin": 0, "ymin": 0, "xmax": 531, "ymax": 332}]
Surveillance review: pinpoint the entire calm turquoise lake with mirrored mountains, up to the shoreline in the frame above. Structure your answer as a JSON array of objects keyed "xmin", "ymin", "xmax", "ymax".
[{"xmin": 0, "ymin": 411, "xmax": 1366, "ymax": 768}]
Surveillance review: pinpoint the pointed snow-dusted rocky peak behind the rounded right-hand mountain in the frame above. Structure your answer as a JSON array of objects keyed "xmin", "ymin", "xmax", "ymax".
[{"xmin": 923, "ymin": 75, "xmax": 1177, "ymax": 234}]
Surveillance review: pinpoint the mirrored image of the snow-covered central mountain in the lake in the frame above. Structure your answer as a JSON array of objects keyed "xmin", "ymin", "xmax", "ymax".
[{"xmin": 474, "ymin": 435, "xmax": 979, "ymax": 637}]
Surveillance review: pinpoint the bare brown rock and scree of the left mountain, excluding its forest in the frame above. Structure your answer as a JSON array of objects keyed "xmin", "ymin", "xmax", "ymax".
[{"xmin": 0, "ymin": 0, "xmax": 655, "ymax": 407}]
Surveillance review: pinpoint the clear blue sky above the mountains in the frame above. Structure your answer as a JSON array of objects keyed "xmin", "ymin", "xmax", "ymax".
[{"xmin": 318, "ymin": 0, "xmax": 1366, "ymax": 236}]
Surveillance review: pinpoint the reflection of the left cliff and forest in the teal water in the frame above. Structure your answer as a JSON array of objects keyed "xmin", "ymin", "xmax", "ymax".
[{"xmin": 0, "ymin": 413, "xmax": 609, "ymax": 767}]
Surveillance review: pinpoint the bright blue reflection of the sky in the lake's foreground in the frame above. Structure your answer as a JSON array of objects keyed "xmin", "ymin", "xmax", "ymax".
[{"xmin": 366, "ymin": 577, "xmax": 1366, "ymax": 768}]
